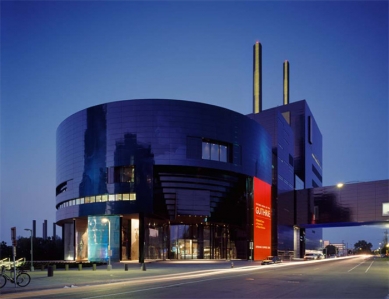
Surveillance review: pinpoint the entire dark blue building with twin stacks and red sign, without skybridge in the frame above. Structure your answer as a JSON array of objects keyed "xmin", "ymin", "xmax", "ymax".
[{"xmin": 56, "ymin": 42, "xmax": 322, "ymax": 262}]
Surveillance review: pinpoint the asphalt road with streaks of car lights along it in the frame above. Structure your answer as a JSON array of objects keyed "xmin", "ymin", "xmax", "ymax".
[{"xmin": 4, "ymin": 257, "xmax": 389, "ymax": 299}]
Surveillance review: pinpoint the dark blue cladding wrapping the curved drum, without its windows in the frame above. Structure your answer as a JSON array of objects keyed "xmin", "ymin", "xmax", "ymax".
[{"xmin": 56, "ymin": 100, "xmax": 271, "ymax": 221}]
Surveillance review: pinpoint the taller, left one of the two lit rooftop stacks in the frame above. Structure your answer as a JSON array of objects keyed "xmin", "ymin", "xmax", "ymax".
[{"xmin": 253, "ymin": 41, "xmax": 262, "ymax": 113}]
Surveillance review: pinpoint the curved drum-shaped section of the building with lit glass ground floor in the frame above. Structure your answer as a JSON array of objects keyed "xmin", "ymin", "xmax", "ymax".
[{"xmin": 56, "ymin": 99, "xmax": 272, "ymax": 260}]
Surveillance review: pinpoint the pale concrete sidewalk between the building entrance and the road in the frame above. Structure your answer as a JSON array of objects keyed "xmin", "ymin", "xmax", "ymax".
[{"xmin": 0, "ymin": 260, "xmax": 260, "ymax": 294}]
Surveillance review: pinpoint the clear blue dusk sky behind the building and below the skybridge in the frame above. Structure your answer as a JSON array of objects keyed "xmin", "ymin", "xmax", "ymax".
[{"xmin": 0, "ymin": 1, "xmax": 389, "ymax": 248}]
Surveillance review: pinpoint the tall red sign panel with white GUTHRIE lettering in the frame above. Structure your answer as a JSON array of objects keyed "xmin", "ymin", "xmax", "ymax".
[{"xmin": 253, "ymin": 177, "xmax": 271, "ymax": 260}]
